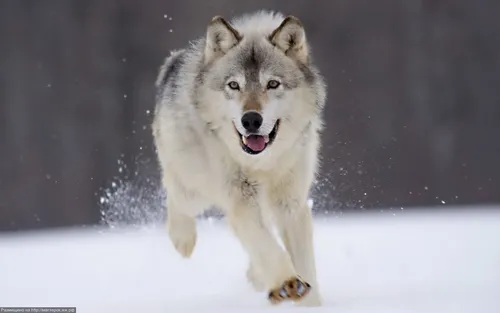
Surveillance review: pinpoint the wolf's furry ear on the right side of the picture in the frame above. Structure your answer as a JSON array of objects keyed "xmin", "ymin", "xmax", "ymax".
[{"xmin": 269, "ymin": 15, "xmax": 309, "ymax": 63}]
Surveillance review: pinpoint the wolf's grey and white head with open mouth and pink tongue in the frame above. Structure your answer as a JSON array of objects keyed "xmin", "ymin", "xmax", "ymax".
[{"xmin": 193, "ymin": 12, "xmax": 325, "ymax": 160}]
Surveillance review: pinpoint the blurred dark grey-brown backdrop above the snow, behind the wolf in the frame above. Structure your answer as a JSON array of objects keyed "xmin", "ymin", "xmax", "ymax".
[{"xmin": 0, "ymin": 0, "xmax": 500, "ymax": 231}]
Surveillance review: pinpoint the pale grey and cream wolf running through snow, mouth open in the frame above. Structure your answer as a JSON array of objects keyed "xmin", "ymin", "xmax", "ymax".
[{"xmin": 152, "ymin": 11, "xmax": 326, "ymax": 306}]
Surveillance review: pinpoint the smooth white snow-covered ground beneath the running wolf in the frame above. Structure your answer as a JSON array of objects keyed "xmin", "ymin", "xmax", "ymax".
[{"xmin": 0, "ymin": 209, "xmax": 500, "ymax": 313}]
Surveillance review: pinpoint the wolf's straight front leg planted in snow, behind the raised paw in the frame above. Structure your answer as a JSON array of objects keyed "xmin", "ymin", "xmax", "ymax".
[{"xmin": 275, "ymin": 198, "xmax": 322, "ymax": 306}]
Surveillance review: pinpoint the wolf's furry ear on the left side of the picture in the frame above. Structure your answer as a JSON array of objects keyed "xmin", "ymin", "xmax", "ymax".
[{"xmin": 205, "ymin": 16, "xmax": 243, "ymax": 63}]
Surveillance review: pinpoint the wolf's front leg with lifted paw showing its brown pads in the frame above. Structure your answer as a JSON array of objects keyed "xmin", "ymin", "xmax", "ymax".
[{"xmin": 227, "ymin": 204, "xmax": 310, "ymax": 304}]
